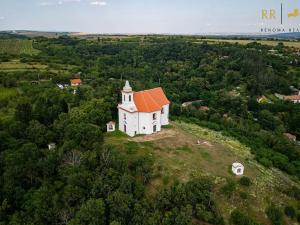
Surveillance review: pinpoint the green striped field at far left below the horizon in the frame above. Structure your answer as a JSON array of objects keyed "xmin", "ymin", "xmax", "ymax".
[{"xmin": 0, "ymin": 39, "xmax": 39, "ymax": 55}]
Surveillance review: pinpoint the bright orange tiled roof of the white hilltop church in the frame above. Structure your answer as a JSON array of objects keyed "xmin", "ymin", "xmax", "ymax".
[{"xmin": 133, "ymin": 87, "xmax": 170, "ymax": 112}]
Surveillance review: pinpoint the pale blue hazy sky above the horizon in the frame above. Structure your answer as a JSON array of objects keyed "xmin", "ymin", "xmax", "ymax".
[{"xmin": 0, "ymin": 0, "xmax": 300, "ymax": 34}]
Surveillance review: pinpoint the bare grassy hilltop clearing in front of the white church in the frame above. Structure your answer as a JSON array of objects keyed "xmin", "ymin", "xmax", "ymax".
[{"xmin": 105, "ymin": 122, "xmax": 299, "ymax": 224}]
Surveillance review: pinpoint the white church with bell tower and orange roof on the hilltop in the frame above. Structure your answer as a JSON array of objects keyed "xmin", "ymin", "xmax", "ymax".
[{"xmin": 118, "ymin": 81, "xmax": 170, "ymax": 137}]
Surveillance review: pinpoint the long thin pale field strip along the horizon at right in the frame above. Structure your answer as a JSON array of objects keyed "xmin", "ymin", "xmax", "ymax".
[{"xmin": 199, "ymin": 39, "xmax": 300, "ymax": 48}]
